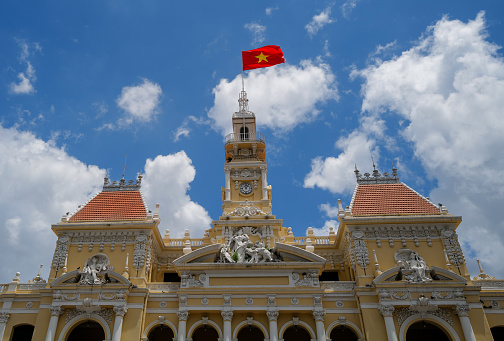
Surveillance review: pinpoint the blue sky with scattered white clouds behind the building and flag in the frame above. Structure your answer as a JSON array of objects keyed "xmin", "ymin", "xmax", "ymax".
[{"xmin": 0, "ymin": 0, "xmax": 504, "ymax": 282}]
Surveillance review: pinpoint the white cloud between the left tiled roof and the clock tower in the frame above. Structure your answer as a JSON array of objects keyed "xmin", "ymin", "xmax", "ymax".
[{"xmin": 143, "ymin": 151, "xmax": 211, "ymax": 238}]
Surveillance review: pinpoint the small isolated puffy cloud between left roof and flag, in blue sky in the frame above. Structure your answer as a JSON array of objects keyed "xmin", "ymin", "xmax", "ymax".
[{"xmin": 116, "ymin": 79, "xmax": 163, "ymax": 126}]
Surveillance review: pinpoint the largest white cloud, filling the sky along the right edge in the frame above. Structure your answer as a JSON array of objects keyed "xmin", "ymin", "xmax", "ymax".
[{"xmin": 347, "ymin": 13, "xmax": 504, "ymax": 278}]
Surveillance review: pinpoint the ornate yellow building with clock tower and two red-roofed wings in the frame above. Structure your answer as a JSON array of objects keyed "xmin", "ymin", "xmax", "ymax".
[{"xmin": 0, "ymin": 92, "xmax": 504, "ymax": 341}]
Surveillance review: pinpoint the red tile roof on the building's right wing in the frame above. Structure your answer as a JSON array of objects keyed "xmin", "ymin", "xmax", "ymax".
[{"xmin": 351, "ymin": 183, "xmax": 440, "ymax": 215}]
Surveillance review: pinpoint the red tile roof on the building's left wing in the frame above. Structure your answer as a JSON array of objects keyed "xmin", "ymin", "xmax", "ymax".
[{"xmin": 69, "ymin": 191, "xmax": 147, "ymax": 222}]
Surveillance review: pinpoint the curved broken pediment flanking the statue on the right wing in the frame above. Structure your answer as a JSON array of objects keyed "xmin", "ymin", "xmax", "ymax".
[{"xmin": 373, "ymin": 266, "xmax": 467, "ymax": 286}]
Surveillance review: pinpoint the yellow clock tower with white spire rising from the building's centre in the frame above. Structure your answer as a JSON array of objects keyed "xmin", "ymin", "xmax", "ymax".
[{"xmin": 213, "ymin": 91, "xmax": 287, "ymax": 247}]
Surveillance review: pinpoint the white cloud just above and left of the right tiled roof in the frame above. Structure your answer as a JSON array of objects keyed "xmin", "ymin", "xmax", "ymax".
[{"xmin": 304, "ymin": 131, "xmax": 379, "ymax": 193}]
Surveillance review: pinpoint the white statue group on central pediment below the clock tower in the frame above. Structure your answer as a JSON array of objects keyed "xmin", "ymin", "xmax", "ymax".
[{"xmin": 218, "ymin": 229, "xmax": 280, "ymax": 263}]
